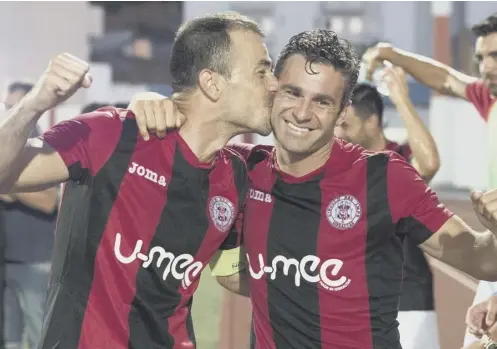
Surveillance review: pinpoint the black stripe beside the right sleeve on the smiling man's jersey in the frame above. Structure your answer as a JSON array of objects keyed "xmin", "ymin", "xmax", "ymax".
[{"xmin": 366, "ymin": 154, "xmax": 403, "ymax": 349}]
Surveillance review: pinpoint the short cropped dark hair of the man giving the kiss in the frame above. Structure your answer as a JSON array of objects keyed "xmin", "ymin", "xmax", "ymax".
[{"xmin": 169, "ymin": 12, "xmax": 264, "ymax": 92}]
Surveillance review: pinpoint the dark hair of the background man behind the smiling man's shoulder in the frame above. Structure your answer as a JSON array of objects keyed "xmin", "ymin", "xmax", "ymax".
[{"xmin": 352, "ymin": 83, "xmax": 384, "ymax": 126}]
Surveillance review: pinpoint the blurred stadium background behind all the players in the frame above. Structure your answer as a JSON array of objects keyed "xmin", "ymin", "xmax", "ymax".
[{"xmin": 0, "ymin": 1, "xmax": 495, "ymax": 349}]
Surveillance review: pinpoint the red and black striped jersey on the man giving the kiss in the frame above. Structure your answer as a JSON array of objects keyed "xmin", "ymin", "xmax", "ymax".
[{"xmin": 39, "ymin": 108, "xmax": 248, "ymax": 349}]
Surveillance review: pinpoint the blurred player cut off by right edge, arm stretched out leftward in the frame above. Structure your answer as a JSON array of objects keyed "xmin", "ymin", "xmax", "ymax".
[{"xmin": 363, "ymin": 13, "xmax": 497, "ymax": 340}]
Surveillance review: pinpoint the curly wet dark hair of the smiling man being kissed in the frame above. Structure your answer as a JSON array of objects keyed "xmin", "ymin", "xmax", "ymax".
[{"xmin": 274, "ymin": 29, "xmax": 360, "ymax": 107}]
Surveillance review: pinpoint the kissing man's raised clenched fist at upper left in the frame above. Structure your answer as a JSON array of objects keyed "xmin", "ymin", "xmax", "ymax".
[{"xmin": 25, "ymin": 53, "xmax": 92, "ymax": 113}]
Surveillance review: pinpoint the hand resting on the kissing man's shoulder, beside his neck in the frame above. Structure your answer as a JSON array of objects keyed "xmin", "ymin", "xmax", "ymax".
[{"xmin": 128, "ymin": 92, "xmax": 186, "ymax": 140}]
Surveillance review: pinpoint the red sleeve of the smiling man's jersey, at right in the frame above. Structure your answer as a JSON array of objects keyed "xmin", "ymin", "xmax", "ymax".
[{"xmin": 387, "ymin": 153, "xmax": 453, "ymax": 244}]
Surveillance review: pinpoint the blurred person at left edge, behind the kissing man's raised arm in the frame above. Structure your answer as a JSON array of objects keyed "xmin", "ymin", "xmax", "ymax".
[{"xmin": 0, "ymin": 82, "xmax": 58, "ymax": 349}]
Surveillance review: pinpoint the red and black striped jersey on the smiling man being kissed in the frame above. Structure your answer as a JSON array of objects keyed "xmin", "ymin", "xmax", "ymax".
[{"xmin": 231, "ymin": 139, "xmax": 451, "ymax": 349}]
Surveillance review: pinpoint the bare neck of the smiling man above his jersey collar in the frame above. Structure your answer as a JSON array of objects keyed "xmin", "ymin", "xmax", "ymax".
[{"xmin": 276, "ymin": 141, "xmax": 333, "ymax": 177}]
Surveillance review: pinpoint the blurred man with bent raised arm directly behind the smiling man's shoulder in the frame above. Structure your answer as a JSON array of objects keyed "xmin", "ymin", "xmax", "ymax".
[{"xmin": 335, "ymin": 67, "xmax": 440, "ymax": 349}]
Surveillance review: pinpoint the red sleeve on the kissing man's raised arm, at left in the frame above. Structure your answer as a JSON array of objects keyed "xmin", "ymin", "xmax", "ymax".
[{"xmin": 40, "ymin": 108, "xmax": 123, "ymax": 181}]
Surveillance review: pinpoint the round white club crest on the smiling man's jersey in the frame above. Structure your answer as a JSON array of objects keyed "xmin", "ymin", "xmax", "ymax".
[{"xmin": 326, "ymin": 195, "xmax": 362, "ymax": 230}]
